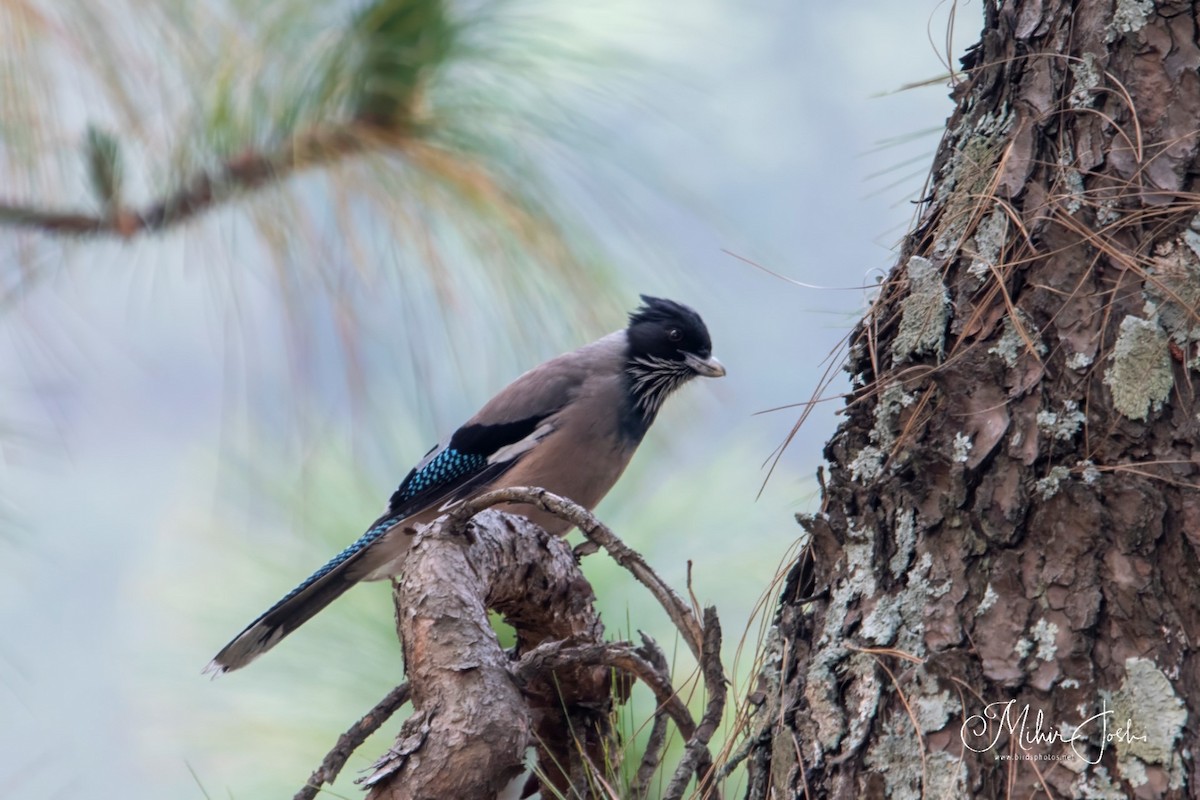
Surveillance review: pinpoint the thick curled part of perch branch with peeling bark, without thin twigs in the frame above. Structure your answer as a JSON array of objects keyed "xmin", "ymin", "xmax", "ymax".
[{"xmin": 366, "ymin": 511, "xmax": 595, "ymax": 800}]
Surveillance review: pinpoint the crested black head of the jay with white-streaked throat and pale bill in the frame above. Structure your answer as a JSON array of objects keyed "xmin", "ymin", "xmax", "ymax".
[{"xmin": 625, "ymin": 295, "xmax": 725, "ymax": 426}]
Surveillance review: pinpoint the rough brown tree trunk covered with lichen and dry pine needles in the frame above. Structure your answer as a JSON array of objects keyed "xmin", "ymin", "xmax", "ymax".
[{"xmin": 748, "ymin": 0, "xmax": 1200, "ymax": 799}]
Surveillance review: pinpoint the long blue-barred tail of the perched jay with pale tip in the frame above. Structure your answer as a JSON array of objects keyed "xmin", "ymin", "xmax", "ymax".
[{"xmin": 204, "ymin": 519, "xmax": 396, "ymax": 675}]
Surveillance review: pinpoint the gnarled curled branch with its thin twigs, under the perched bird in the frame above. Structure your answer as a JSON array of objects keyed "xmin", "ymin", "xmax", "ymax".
[{"xmin": 298, "ymin": 488, "xmax": 725, "ymax": 800}]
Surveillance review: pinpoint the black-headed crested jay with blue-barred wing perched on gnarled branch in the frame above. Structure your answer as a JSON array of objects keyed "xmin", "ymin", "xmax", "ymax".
[{"xmin": 204, "ymin": 295, "xmax": 725, "ymax": 676}]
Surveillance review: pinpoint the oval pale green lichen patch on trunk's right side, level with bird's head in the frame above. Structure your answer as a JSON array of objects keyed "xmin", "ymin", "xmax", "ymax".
[{"xmin": 1104, "ymin": 315, "xmax": 1175, "ymax": 420}]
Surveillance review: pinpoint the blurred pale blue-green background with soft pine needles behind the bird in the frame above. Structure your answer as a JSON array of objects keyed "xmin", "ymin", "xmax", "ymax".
[{"xmin": 0, "ymin": 0, "xmax": 980, "ymax": 800}]
